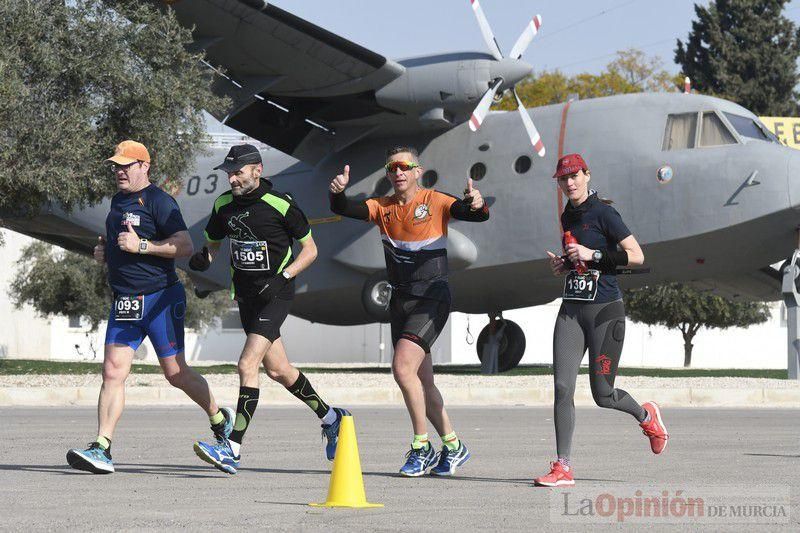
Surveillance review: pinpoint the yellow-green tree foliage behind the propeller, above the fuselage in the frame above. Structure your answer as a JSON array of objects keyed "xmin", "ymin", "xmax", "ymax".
[{"xmin": 497, "ymin": 48, "xmax": 682, "ymax": 110}]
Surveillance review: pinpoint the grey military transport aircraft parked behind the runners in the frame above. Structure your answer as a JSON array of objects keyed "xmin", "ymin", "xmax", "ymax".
[{"xmin": 4, "ymin": 0, "xmax": 800, "ymax": 369}]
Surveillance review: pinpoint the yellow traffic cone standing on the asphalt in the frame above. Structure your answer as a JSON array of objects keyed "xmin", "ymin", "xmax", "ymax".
[{"xmin": 309, "ymin": 416, "xmax": 383, "ymax": 507}]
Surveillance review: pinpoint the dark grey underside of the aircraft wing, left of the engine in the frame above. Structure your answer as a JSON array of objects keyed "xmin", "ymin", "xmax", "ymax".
[{"xmin": 158, "ymin": 0, "xmax": 405, "ymax": 163}]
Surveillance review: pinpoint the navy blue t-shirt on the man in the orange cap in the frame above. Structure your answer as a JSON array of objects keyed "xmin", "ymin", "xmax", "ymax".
[{"xmin": 106, "ymin": 184, "xmax": 186, "ymax": 294}]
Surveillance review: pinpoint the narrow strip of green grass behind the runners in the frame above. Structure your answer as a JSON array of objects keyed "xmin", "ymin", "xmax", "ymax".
[{"xmin": 0, "ymin": 359, "xmax": 787, "ymax": 379}]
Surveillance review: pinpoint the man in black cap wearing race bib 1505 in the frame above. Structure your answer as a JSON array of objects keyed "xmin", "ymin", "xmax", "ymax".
[{"xmin": 189, "ymin": 144, "xmax": 350, "ymax": 474}]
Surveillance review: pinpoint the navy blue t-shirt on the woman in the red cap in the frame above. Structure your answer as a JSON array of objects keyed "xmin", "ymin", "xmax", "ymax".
[{"xmin": 561, "ymin": 192, "xmax": 631, "ymax": 303}]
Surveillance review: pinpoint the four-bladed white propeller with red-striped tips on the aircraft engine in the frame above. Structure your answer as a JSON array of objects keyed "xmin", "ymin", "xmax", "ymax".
[{"xmin": 469, "ymin": 0, "xmax": 545, "ymax": 157}]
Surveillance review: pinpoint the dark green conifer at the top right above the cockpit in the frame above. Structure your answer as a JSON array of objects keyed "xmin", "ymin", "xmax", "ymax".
[{"xmin": 675, "ymin": 0, "xmax": 800, "ymax": 116}]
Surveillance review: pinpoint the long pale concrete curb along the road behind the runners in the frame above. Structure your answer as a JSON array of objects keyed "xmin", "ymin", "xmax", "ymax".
[{"xmin": 0, "ymin": 386, "xmax": 800, "ymax": 408}]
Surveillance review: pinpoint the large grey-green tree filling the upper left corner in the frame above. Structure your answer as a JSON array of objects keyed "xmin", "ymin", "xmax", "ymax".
[{"xmin": 0, "ymin": 0, "xmax": 226, "ymax": 216}]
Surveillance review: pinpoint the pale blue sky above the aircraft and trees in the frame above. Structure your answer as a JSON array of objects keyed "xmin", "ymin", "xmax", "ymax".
[{"xmin": 271, "ymin": 0, "xmax": 800, "ymax": 74}]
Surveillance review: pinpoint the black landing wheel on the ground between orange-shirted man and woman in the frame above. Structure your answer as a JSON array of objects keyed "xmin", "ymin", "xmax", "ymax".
[{"xmin": 475, "ymin": 313, "xmax": 525, "ymax": 374}]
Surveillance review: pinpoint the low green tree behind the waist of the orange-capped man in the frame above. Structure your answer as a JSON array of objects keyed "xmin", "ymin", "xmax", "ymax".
[{"xmin": 9, "ymin": 242, "xmax": 231, "ymax": 331}]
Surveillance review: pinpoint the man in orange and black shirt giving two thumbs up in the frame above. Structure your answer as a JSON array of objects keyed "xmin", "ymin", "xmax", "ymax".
[{"xmin": 330, "ymin": 146, "xmax": 489, "ymax": 477}]
